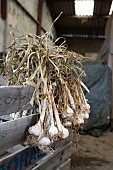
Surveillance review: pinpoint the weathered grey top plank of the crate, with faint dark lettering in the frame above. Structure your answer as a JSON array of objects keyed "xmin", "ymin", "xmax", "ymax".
[{"xmin": 0, "ymin": 86, "xmax": 34, "ymax": 115}]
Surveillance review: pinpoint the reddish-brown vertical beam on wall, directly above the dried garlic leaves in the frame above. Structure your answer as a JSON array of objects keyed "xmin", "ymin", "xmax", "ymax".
[{"xmin": 37, "ymin": 0, "xmax": 43, "ymax": 35}]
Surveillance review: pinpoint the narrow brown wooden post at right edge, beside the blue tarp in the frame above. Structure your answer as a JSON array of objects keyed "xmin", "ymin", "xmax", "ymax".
[{"xmin": 108, "ymin": 18, "xmax": 113, "ymax": 129}]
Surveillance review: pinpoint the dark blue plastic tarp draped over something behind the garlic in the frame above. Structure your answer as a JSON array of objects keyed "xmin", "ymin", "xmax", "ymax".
[{"xmin": 80, "ymin": 61, "xmax": 111, "ymax": 136}]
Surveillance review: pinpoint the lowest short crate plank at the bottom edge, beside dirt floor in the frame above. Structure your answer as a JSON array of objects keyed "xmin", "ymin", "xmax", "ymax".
[{"xmin": 56, "ymin": 158, "xmax": 71, "ymax": 170}]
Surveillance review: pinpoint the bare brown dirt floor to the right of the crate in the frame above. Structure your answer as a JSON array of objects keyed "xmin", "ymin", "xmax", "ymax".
[{"xmin": 71, "ymin": 132, "xmax": 113, "ymax": 170}]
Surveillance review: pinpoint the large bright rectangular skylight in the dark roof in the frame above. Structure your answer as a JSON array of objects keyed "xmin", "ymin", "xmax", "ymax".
[{"xmin": 75, "ymin": 0, "xmax": 94, "ymax": 16}]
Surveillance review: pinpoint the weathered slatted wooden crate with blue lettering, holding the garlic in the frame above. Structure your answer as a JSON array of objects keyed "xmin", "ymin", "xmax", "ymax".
[{"xmin": 0, "ymin": 86, "xmax": 73, "ymax": 170}]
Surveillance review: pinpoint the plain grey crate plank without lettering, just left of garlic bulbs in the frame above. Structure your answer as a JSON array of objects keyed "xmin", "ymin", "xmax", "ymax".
[{"xmin": 0, "ymin": 114, "xmax": 38, "ymax": 152}]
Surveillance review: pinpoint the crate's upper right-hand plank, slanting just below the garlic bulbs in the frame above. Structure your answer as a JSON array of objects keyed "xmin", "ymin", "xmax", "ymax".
[{"xmin": 32, "ymin": 142, "xmax": 72, "ymax": 170}]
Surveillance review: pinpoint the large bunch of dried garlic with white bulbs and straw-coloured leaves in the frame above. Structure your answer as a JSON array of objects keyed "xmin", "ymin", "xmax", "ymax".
[{"xmin": 4, "ymin": 34, "xmax": 90, "ymax": 149}]
